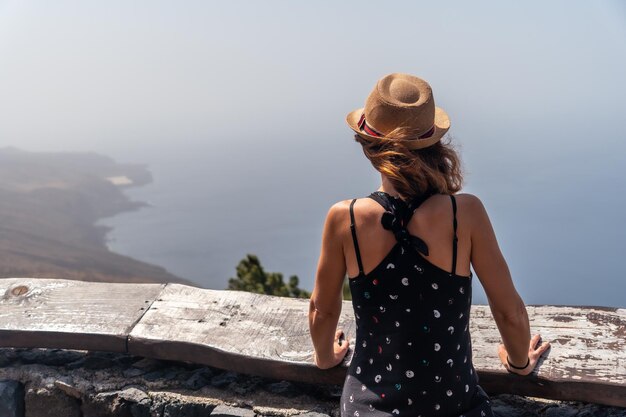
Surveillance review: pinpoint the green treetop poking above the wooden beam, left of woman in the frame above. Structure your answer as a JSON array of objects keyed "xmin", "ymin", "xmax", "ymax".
[{"xmin": 228, "ymin": 254, "xmax": 311, "ymax": 298}]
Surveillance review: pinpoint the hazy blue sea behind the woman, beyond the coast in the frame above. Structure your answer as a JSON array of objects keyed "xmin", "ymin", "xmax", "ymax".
[{"xmin": 101, "ymin": 120, "xmax": 626, "ymax": 307}]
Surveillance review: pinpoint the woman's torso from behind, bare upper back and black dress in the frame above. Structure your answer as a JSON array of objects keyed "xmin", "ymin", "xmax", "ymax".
[{"xmin": 341, "ymin": 192, "xmax": 488, "ymax": 416}]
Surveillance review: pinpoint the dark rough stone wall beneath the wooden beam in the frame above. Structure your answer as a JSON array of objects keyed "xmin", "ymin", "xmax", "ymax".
[{"xmin": 0, "ymin": 348, "xmax": 626, "ymax": 417}]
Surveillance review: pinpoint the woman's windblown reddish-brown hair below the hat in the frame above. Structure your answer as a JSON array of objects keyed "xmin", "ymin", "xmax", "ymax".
[{"xmin": 354, "ymin": 131, "xmax": 463, "ymax": 200}]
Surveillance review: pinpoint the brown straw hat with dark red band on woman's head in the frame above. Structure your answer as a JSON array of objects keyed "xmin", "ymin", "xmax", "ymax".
[{"xmin": 346, "ymin": 73, "xmax": 450, "ymax": 149}]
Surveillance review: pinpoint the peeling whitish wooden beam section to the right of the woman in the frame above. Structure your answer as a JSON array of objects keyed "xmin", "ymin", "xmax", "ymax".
[{"xmin": 470, "ymin": 306, "xmax": 626, "ymax": 407}]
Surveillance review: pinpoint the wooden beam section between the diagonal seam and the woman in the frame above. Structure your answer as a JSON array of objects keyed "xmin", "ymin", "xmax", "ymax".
[{"xmin": 128, "ymin": 284, "xmax": 355, "ymax": 383}]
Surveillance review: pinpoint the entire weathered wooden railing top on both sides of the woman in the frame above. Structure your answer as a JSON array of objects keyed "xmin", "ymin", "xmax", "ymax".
[{"xmin": 0, "ymin": 278, "xmax": 626, "ymax": 407}]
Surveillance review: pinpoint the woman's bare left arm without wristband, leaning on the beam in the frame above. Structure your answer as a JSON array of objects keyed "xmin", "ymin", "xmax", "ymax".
[{"xmin": 309, "ymin": 202, "xmax": 349, "ymax": 369}]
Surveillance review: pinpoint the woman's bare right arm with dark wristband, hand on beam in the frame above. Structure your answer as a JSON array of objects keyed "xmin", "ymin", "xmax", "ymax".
[{"xmin": 466, "ymin": 195, "xmax": 550, "ymax": 375}]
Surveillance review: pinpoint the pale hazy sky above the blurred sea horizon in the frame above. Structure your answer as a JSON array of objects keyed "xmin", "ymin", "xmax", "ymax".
[{"xmin": 0, "ymin": 0, "xmax": 626, "ymax": 154}]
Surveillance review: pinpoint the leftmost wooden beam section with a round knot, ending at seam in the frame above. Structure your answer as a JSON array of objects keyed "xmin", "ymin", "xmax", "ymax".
[{"xmin": 0, "ymin": 278, "xmax": 165, "ymax": 352}]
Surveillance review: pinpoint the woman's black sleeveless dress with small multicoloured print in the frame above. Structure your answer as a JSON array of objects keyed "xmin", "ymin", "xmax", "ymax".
[{"xmin": 340, "ymin": 192, "xmax": 493, "ymax": 417}]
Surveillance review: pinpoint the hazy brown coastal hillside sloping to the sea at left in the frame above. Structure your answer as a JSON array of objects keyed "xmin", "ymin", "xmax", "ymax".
[{"xmin": 0, "ymin": 148, "xmax": 189, "ymax": 284}]
